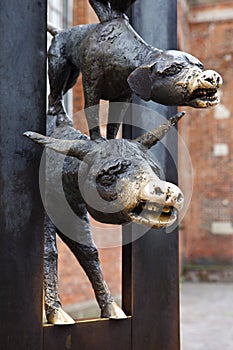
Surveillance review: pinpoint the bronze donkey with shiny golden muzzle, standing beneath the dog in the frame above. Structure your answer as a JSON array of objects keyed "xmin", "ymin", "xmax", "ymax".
[{"xmin": 24, "ymin": 113, "xmax": 184, "ymax": 325}]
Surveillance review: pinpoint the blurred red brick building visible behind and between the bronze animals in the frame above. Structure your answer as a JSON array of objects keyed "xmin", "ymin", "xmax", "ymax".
[{"xmin": 48, "ymin": 0, "xmax": 233, "ymax": 317}]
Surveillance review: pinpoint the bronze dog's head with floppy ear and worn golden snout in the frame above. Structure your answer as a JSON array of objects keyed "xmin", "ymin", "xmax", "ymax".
[{"xmin": 128, "ymin": 50, "xmax": 222, "ymax": 108}]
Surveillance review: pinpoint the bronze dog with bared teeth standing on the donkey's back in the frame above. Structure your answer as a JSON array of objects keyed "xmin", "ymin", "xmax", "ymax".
[{"xmin": 48, "ymin": 0, "xmax": 222, "ymax": 139}]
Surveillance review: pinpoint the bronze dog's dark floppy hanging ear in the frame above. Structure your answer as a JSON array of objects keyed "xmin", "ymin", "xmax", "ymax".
[{"xmin": 127, "ymin": 63, "xmax": 155, "ymax": 101}]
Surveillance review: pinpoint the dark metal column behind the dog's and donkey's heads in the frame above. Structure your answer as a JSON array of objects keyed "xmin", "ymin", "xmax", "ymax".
[{"xmin": 124, "ymin": 0, "xmax": 180, "ymax": 350}]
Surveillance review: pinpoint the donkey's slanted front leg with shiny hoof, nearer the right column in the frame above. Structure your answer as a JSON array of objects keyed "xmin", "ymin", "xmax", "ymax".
[{"xmin": 58, "ymin": 232, "xmax": 127, "ymax": 319}]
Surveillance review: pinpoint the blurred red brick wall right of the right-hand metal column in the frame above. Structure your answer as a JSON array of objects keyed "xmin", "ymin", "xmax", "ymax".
[{"xmin": 179, "ymin": 0, "xmax": 233, "ymax": 276}]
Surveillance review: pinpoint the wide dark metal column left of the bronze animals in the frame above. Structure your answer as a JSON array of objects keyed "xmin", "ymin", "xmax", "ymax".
[{"xmin": 0, "ymin": 0, "xmax": 47, "ymax": 350}]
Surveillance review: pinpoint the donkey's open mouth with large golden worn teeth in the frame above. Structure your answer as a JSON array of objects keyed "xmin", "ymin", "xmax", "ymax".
[{"xmin": 129, "ymin": 201, "xmax": 177, "ymax": 228}]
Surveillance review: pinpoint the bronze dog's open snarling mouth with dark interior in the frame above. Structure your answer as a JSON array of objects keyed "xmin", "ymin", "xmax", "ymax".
[{"xmin": 189, "ymin": 88, "xmax": 220, "ymax": 108}]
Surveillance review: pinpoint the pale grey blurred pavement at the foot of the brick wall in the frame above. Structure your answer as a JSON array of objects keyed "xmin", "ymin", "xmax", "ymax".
[{"xmin": 181, "ymin": 283, "xmax": 233, "ymax": 350}]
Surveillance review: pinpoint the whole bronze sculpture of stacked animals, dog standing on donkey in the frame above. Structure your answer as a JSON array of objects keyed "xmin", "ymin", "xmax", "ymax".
[{"xmin": 25, "ymin": 0, "xmax": 222, "ymax": 324}]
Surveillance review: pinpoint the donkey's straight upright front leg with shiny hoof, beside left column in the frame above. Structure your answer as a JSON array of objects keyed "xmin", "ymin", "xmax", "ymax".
[{"xmin": 44, "ymin": 215, "xmax": 75, "ymax": 325}]
